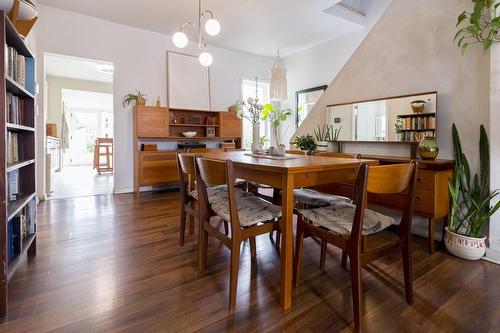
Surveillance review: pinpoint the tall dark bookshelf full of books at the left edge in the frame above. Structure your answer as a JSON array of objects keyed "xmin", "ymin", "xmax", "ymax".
[{"xmin": 0, "ymin": 11, "xmax": 37, "ymax": 318}]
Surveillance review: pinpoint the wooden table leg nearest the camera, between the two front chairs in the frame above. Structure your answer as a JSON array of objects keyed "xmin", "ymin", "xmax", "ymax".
[{"xmin": 281, "ymin": 174, "xmax": 293, "ymax": 310}]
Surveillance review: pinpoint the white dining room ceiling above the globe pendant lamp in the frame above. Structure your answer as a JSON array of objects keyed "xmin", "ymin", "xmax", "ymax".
[{"xmin": 39, "ymin": 0, "xmax": 368, "ymax": 56}]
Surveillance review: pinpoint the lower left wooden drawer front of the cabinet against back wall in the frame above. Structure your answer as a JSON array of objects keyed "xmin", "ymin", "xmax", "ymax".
[{"xmin": 139, "ymin": 152, "xmax": 179, "ymax": 186}]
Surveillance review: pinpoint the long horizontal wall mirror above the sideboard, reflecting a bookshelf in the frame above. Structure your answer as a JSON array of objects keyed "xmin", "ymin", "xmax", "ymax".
[{"xmin": 326, "ymin": 92, "xmax": 437, "ymax": 142}]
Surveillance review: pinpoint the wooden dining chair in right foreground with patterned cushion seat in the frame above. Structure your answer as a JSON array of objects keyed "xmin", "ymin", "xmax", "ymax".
[{"xmin": 294, "ymin": 162, "xmax": 417, "ymax": 332}]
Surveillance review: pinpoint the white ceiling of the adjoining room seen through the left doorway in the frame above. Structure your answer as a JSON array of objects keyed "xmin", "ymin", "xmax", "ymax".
[{"xmin": 44, "ymin": 54, "xmax": 113, "ymax": 83}]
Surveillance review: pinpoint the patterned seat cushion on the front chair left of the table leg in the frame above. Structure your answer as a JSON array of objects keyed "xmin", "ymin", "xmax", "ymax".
[{"xmin": 210, "ymin": 196, "xmax": 281, "ymax": 227}]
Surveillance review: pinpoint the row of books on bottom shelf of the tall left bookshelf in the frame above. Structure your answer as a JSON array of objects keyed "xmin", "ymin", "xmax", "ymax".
[{"xmin": 7, "ymin": 198, "xmax": 36, "ymax": 263}]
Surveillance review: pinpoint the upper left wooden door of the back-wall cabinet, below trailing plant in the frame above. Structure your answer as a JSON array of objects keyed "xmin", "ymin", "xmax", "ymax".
[{"xmin": 135, "ymin": 106, "xmax": 168, "ymax": 138}]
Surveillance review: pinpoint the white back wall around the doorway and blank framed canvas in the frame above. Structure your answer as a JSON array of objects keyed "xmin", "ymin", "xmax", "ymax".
[{"xmin": 37, "ymin": 5, "xmax": 273, "ymax": 193}]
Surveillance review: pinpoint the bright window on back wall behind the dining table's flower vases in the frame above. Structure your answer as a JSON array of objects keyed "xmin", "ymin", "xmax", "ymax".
[{"xmin": 241, "ymin": 78, "xmax": 271, "ymax": 149}]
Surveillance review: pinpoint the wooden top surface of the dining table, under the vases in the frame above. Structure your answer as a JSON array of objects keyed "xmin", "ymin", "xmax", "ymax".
[{"xmin": 201, "ymin": 151, "xmax": 378, "ymax": 171}]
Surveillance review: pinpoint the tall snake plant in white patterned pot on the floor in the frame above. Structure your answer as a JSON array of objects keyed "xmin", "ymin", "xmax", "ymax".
[{"xmin": 445, "ymin": 124, "xmax": 500, "ymax": 260}]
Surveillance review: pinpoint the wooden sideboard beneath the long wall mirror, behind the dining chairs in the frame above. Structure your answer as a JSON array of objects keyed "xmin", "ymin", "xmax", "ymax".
[{"xmin": 319, "ymin": 155, "xmax": 455, "ymax": 253}]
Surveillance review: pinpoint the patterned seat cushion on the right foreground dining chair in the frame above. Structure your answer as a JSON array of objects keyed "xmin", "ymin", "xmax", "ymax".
[{"xmin": 299, "ymin": 203, "xmax": 396, "ymax": 236}]
